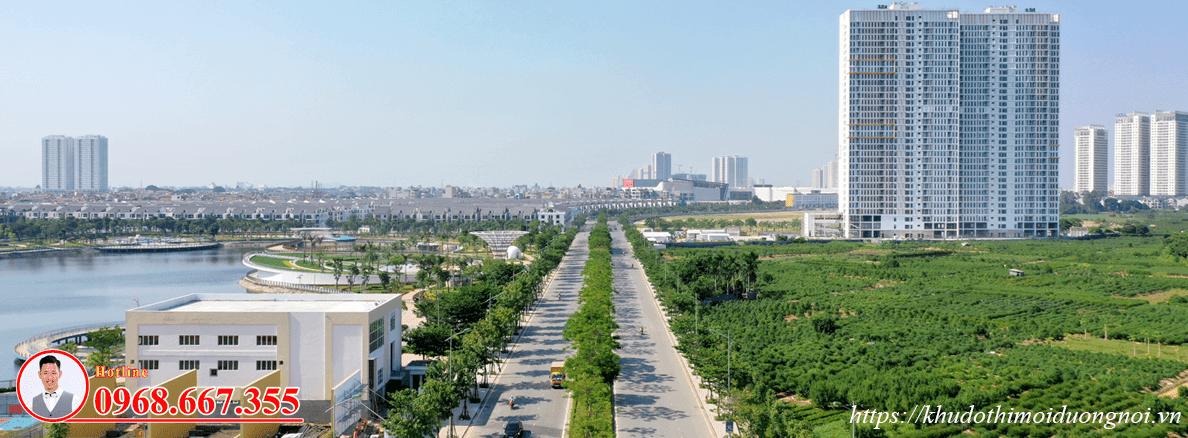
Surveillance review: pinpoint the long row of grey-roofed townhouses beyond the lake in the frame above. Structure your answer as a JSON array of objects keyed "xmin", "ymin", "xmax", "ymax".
[{"xmin": 0, "ymin": 199, "xmax": 573, "ymax": 224}]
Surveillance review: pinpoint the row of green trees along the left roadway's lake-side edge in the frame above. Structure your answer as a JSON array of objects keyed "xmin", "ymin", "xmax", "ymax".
[{"xmin": 384, "ymin": 229, "xmax": 577, "ymax": 437}]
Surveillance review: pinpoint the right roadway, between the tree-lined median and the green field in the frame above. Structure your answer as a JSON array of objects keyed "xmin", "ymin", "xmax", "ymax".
[{"xmin": 611, "ymin": 224, "xmax": 716, "ymax": 438}]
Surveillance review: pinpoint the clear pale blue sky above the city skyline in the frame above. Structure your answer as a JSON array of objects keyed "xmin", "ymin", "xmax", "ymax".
[{"xmin": 0, "ymin": 0, "xmax": 1188, "ymax": 189}]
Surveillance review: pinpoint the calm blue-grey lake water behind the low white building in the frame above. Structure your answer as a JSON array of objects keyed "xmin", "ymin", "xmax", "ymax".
[{"xmin": 0, "ymin": 248, "xmax": 251, "ymax": 380}]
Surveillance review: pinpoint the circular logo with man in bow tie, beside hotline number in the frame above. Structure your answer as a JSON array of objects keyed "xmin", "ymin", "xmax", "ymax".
[{"xmin": 17, "ymin": 350, "xmax": 90, "ymax": 423}]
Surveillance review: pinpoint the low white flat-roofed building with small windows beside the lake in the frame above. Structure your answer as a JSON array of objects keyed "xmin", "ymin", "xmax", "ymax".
[{"xmin": 125, "ymin": 293, "xmax": 402, "ymax": 401}]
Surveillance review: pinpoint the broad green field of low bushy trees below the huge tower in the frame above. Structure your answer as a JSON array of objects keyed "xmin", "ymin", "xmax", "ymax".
[{"xmin": 636, "ymin": 236, "xmax": 1188, "ymax": 437}]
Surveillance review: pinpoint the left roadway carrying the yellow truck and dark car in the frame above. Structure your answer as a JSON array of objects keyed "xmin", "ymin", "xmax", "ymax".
[{"xmin": 466, "ymin": 231, "xmax": 589, "ymax": 438}]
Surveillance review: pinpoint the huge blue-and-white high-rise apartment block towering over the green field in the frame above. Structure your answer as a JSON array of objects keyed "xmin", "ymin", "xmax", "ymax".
[{"xmin": 839, "ymin": 2, "xmax": 1060, "ymax": 239}]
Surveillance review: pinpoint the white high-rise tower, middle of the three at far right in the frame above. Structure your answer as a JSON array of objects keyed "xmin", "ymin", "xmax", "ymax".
[{"xmin": 1113, "ymin": 112, "xmax": 1151, "ymax": 196}]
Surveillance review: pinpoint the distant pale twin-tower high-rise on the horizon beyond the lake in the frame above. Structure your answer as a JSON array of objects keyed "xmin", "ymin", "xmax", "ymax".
[{"xmin": 42, "ymin": 135, "xmax": 107, "ymax": 191}]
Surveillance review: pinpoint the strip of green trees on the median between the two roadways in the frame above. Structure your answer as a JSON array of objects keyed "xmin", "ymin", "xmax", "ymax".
[{"xmin": 562, "ymin": 214, "xmax": 620, "ymax": 438}]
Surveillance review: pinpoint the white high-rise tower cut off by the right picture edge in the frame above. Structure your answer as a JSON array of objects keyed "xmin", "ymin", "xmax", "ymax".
[{"xmin": 1150, "ymin": 112, "xmax": 1188, "ymax": 196}]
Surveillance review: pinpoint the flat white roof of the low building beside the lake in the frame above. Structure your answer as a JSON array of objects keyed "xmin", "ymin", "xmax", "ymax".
[{"xmin": 129, "ymin": 293, "xmax": 400, "ymax": 313}]
